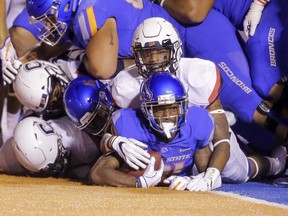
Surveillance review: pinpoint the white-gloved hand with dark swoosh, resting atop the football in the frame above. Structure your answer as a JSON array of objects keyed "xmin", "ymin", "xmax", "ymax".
[{"xmin": 110, "ymin": 136, "xmax": 150, "ymax": 170}]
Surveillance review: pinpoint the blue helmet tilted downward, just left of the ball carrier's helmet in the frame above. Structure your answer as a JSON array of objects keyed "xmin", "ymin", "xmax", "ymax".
[{"xmin": 64, "ymin": 76, "xmax": 114, "ymax": 135}]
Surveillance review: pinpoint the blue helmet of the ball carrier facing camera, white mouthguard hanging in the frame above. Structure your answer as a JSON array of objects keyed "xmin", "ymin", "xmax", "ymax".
[{"xmin": 140, "ymin": 72, "xmax": 188, "ymax": 139}]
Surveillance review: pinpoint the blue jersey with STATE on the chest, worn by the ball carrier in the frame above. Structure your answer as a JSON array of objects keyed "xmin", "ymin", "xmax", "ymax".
[{"xmin": 112, "ymin": 107, "xmax": 214, "ymax": 176}]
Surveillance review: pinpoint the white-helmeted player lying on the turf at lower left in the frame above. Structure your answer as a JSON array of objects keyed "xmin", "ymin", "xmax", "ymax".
[{"xmin": 0, "ymin": 116, "xmax": 100, "ymax": 179}]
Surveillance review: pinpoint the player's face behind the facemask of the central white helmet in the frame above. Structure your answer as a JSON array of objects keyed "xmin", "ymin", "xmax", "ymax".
[{"xmin": 143, "ymin": 48, "xmax": 170, "ymax": 72}]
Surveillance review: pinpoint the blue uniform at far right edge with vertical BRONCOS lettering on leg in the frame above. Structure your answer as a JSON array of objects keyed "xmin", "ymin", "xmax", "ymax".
[{"xmin": 214, "ymin": 0, "xmax": 288, "ymax": 99}]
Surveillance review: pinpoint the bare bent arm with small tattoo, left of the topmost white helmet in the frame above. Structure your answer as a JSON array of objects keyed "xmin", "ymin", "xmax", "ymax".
[{"xmin": 83, "ymin": 18, "xmax": 118, "ymax": 79}]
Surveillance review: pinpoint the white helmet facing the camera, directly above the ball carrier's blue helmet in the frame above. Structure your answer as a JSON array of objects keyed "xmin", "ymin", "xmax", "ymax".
[{"xmin": 132, "ymin": 17, "xmax": 182, "ymax": 77}]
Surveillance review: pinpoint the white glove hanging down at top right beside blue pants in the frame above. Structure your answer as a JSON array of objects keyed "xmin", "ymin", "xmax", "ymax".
[{"xmin": 243, "ymin": 0, "xmax": 270, "ymax": 38}]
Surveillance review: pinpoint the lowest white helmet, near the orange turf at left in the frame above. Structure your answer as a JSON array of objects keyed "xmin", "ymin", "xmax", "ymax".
[{"xmin": 12, "ymin": 117, "xmax": 69, "ymax": 176}]
